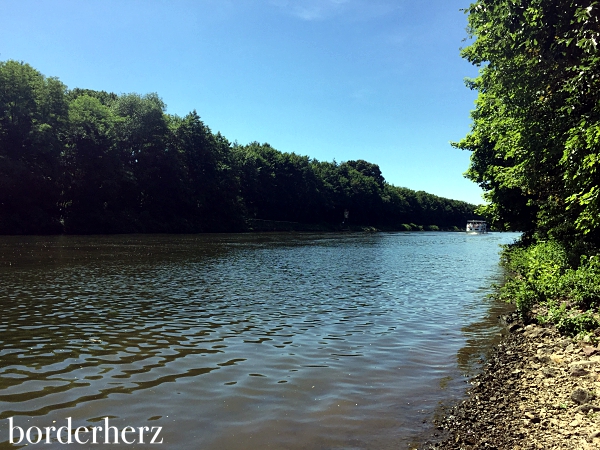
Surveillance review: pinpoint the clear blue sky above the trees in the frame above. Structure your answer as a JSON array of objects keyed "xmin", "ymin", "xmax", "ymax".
[{"xmin": 0, "ymin": 0, "xmax": 483, "ymax": 204}]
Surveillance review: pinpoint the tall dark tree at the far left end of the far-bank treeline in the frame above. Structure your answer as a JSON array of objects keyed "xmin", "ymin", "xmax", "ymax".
[{"xmin": 0, "ymin": 61, "xmax": 67, "ymax": 234}]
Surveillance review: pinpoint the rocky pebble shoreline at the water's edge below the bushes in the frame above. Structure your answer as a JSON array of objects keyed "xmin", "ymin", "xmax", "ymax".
[{"xmin": 421, "ymin": 322, "xmax": 600, "ymax": 450}]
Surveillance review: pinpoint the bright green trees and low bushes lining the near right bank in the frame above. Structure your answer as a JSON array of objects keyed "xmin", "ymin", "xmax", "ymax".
[{"xmin": 456, "ymin": 0, "xmax": 600, "ymax": 333}]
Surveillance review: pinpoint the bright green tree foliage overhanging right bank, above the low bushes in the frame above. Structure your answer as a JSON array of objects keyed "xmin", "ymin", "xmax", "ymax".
[{"xmin": 455, "ymin": 0, "xmax": 600, "ymax": 250}]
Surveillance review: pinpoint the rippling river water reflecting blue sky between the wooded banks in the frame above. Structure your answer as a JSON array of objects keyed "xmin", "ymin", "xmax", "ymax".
[{"xmin": 0, "ymin": 232, "xmax": 517, "ymax": 450}]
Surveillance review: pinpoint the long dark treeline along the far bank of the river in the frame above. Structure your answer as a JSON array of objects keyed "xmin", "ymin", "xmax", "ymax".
[{"xmin": 0, "ymin": 61, "xmax": 474, "ymax": 234}]
